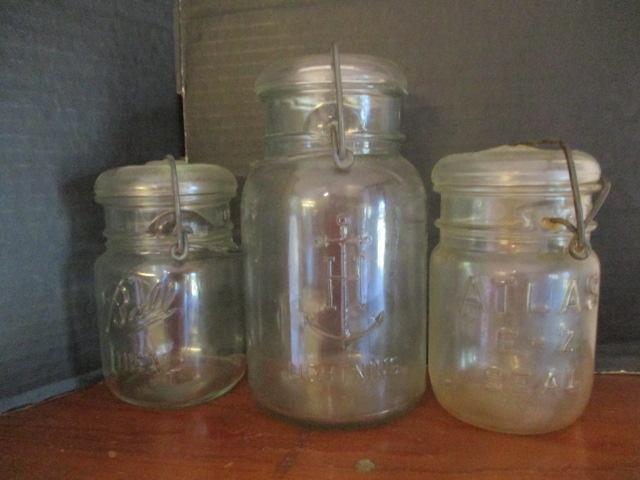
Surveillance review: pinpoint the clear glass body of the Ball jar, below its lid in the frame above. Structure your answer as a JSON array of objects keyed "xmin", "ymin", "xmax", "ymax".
[{"xmin": 95, "ymin": 202, "xmax": 245, "ymax": 408}]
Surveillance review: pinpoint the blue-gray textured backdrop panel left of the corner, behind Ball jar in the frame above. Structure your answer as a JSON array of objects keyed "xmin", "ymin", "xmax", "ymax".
[{"xmin": 0, "ymin": 0, "xmax": 182, "ymax": 411}]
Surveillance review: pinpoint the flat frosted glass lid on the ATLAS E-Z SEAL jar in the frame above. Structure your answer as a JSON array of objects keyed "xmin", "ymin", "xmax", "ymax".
[{"xmin": 431, "ymin": 145, "xmax": 600, "ymax": 190}]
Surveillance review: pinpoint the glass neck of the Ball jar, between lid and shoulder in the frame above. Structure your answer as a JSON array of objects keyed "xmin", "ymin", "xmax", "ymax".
[{"xmin": 104, "ymin": 203, "xmax": 237, "ymax": 255}]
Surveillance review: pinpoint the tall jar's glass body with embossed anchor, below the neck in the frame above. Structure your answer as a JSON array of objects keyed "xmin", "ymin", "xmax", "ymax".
[{"xmin": 242, "ymin": 149, "xmax": 426, "ymax": 425}]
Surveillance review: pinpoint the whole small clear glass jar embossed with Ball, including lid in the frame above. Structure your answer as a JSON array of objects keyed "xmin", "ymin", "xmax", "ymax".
[{"xmin": 95, "ymin": 159, "xmax": 245, "ymax": 408}]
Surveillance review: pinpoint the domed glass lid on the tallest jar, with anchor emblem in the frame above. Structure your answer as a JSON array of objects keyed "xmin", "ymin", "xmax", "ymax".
[{"xmin": 256, "ymin": 54, "xmax": 407, "ymax": 95}]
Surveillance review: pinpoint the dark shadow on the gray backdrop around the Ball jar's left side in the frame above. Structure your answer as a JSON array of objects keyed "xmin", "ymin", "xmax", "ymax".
[{"xmin": 60, "ymin": 102, "xmax": 184, "ymax": 385}]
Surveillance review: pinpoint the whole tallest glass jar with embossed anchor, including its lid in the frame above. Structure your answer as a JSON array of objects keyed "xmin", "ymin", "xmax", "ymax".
[{"xmin": 242, "ymin": 55, "xmax": 426, "ymax": 425}]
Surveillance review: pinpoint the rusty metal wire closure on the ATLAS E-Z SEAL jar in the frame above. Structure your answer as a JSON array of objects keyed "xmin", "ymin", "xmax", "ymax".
[{"xmin": 522, "ymin": 139, "xmax": 611, "ymax": 260}]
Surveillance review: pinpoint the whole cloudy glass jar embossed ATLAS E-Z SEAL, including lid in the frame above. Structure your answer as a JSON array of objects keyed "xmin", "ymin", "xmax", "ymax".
[{"xmin": 429, "ymin": 146, "xmax": 601, "ymax": 434}]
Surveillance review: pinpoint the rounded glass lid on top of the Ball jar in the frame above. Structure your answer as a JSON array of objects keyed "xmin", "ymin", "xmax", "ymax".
[{"xmin": 94, "ymin": 160, "xmax": 238, "ymax": 202}]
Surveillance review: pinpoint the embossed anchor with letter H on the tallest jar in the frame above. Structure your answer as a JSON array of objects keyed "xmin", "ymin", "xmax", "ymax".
[{"xmin": 304, "ymin": 214, "xmax": 384, "ymax": 347}]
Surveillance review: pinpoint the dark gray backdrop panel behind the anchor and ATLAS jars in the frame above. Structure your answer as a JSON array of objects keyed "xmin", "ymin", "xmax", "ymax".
[{"xmin": 182, "ymin": 0, "xmax": 640, "ymax": 370}]
